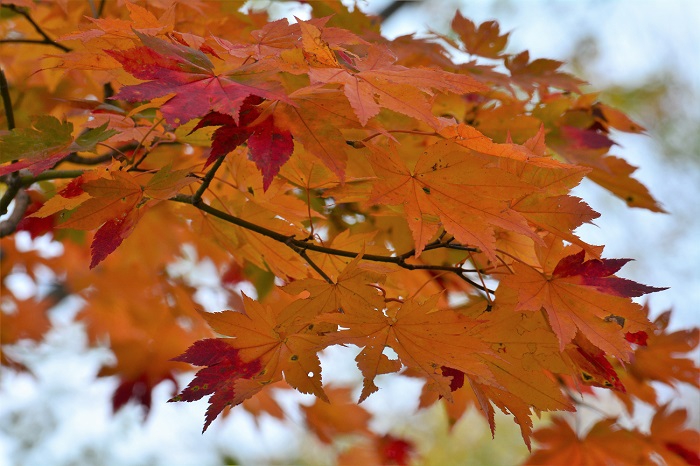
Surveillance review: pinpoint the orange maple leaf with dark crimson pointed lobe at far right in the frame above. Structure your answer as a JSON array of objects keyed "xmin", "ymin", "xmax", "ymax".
[{"xmin": 499, "ymin": 239, "xmax": 665, "ymax": 361}]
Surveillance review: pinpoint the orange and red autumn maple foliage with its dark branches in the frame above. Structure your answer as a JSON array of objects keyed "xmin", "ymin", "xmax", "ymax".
[{"xmin": 0, "ymin": 0, "xmax": 700, "ymax": 464}]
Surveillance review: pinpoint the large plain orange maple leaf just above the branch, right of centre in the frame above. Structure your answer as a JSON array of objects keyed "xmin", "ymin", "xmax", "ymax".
[{"xmin": 369, "ymin": 141, "xmax": 535, "ymax": 261}]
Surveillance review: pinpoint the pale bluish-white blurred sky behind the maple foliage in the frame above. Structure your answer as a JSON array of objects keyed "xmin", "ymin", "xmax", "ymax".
[{"xmin": 0, "ymin": 0, "xmax": 700, "ymax": 466}]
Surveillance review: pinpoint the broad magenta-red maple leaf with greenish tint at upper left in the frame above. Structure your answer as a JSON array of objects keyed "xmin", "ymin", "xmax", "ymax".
[{"xmin": 106, "ymin": 32, "xmax": 289, "ymax": 124}]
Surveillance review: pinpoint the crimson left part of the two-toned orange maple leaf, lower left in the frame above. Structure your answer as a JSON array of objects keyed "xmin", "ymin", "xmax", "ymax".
[{"xmin": 168, "ymin": 338, "xmax": 263, "ymax": 432}]
